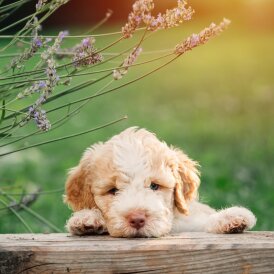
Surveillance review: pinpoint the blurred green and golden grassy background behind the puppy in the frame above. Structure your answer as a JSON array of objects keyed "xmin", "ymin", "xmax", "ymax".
[{"xmin": 0, "ymin": 0, "xmax": 274, "ymax": 233}]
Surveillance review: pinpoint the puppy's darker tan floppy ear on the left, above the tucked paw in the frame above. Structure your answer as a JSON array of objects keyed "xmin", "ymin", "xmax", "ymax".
[{"xmin": 64, "ymin": 151, "xmax": 96, "ymax": 211}]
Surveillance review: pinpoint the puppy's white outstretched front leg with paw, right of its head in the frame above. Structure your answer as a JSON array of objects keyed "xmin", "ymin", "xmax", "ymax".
[{"xmin": 172, "ymin": 201, "xmax": 256, "ymax": 233}]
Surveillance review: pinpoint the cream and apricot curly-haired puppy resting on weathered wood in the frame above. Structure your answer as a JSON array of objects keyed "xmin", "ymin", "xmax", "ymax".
[{"xmin": 64, "ymin": 127, "xmax": 256, "ymax": 237}]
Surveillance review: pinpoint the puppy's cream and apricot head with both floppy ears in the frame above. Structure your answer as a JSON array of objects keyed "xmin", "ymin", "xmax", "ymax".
[{"xmin": 65, "ymin": 128, "xmax": 200, "ymax": 237}]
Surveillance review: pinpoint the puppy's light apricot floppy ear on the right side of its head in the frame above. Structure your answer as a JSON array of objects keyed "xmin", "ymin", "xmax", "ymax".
[{"xmin": 173, "ymin": 148, "xmax": 200, "ymax": 215}]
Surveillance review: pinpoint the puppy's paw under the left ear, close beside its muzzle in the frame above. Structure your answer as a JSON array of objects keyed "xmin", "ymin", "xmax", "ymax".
[{"xmin": 66, "ymin": 209, "xmax": 107, "ymax": 235}]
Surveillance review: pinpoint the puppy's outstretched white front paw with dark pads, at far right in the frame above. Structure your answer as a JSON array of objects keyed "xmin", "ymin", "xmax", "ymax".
[{"xmin": 207, "ymin": 207, "xmax": 256, "ymax": 233}]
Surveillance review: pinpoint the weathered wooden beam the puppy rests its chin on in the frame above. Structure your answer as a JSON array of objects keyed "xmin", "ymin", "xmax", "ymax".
[{"xmin": 0, "ymin": 232, "xmax": 274, "ymax": 274}]
